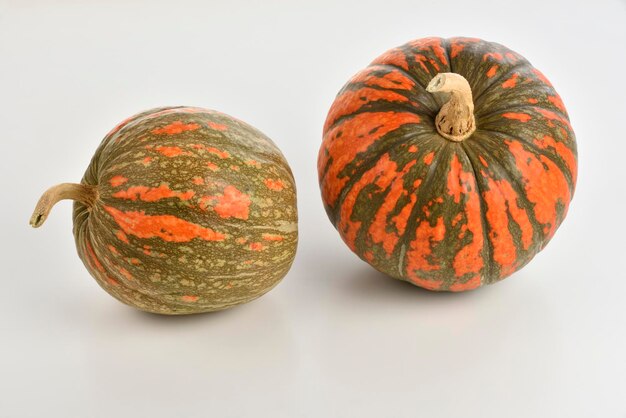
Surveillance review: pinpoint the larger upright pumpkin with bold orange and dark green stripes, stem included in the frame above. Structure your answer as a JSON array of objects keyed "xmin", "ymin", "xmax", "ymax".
[{"xmin": 318, "ymin": 38, "xmax": 577, "ymax": 291}]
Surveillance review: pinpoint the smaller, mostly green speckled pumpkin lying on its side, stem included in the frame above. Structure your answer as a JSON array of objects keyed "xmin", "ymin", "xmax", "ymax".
[{"xmin": 31, "ymin": 107, "xmax": 298, "ymax": 314}]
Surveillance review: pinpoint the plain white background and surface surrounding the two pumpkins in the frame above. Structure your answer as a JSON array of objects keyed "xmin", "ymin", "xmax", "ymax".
[{"xmin": 0, "ymin": 0, "xmax": 626, "ymax": 418}]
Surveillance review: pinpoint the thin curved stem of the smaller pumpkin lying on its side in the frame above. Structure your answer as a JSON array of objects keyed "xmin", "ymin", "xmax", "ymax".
[{"xmin": 30, "ymin": 183, "xmax": 98, "ymax": 228}]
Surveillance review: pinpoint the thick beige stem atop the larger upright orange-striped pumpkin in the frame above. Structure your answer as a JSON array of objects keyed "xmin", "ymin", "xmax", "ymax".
[{"xmin": 426, "ymin": 73, "xmax": 476, "ymax": 142}]
